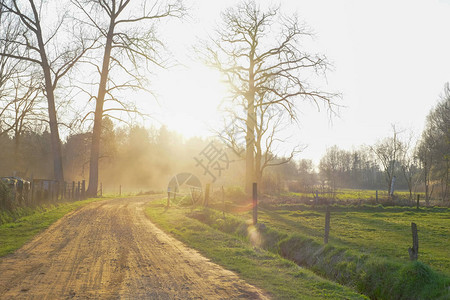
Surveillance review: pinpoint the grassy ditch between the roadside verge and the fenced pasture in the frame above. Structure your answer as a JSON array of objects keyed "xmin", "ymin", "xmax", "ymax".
[{"xmin": 189, "ymin": 209, "xmax": 450, "ymax": 300}]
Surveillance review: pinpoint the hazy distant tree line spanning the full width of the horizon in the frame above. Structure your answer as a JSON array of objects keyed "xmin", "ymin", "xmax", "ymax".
[{"xmin": 0, "ymin": 92, "xmax": 450, "ymax": 201}]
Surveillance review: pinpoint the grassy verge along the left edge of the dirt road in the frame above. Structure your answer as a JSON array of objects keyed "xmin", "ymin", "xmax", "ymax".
[{"xmin": 0, "ymin": 198, "xmax": 105, "ymax": 257}]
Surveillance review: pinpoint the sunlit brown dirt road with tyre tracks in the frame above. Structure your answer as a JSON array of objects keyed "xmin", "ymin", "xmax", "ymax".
[{"xmin": 0, "ymin": 197, "xmax": 265, "ymax": 299}]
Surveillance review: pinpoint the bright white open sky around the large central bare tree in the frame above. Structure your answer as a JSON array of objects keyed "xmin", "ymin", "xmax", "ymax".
[{"xmin": 142, "ymin": 0, "xmax": 450, "ymax": 163}]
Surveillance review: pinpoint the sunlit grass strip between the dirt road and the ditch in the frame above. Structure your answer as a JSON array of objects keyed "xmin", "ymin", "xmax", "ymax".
[{"xmin": 146, "ymin": 200, "xmax": 366, "ymax": 299}]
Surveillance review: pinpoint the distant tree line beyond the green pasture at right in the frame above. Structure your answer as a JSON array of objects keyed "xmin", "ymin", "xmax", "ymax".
[{"xmin": 267, "ymin": 88, "xmax": 450, "ymax": 201}]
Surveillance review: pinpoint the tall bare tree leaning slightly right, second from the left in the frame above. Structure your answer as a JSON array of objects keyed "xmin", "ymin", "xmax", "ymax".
[{"xmin": 72, "ymin": 0, "xmax": 184, "ymax": 196}]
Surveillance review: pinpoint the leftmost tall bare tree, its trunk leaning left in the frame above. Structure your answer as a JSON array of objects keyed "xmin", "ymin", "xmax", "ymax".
[{"xmin": 0, "ymin": 0, "xmax": 89, "ymax": 181}]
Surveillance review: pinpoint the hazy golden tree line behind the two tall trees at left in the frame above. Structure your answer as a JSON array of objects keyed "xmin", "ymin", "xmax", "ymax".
[{"xmin": 0, "ymin": 118, "xmax": 219, "ymax": 192}]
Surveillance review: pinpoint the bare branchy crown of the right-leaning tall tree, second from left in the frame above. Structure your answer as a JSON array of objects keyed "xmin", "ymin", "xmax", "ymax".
[{"xmin": 71, "ymin": 0, "xmax": 185, "ymax": 120}]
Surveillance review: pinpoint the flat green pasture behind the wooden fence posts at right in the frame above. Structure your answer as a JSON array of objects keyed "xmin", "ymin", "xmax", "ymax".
[{"xmin": 259, "ymin": 205, "xmax": 450, "ymax": 275}]
